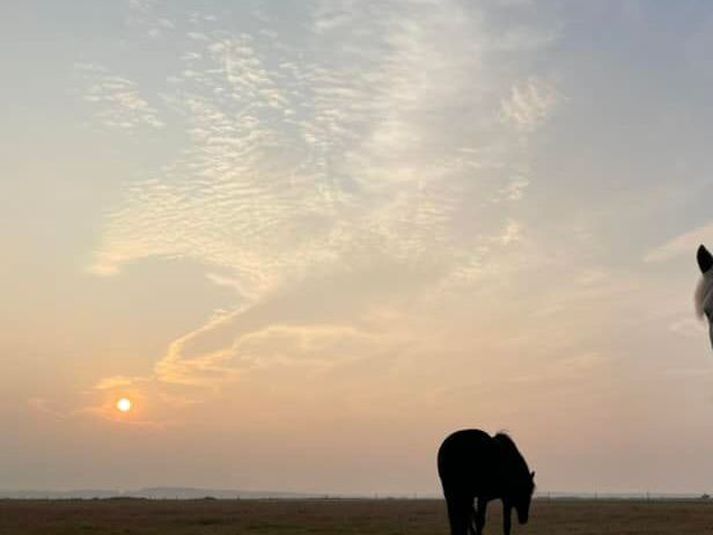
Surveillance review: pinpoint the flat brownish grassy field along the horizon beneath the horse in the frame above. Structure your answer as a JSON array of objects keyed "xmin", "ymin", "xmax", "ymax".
[{"xmin": 0, "ymin": 499, "xmax": 713, "ymax": 535}]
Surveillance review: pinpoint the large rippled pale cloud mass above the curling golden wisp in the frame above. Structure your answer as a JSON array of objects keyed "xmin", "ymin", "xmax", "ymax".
[{"xmin": 91, "ymin": 2, "xmax": 550, "ymax": 288}]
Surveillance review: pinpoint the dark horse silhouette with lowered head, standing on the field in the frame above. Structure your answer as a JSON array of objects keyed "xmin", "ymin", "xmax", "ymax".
[{"xmin": 438, "ymin": 429, "xmax": 535, "ymax": 535}]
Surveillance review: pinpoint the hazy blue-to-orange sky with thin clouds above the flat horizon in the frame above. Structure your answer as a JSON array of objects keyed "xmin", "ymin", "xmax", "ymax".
[{"xmin": 0, "ymin": 0, "xmax": 713, "ymax": 494}]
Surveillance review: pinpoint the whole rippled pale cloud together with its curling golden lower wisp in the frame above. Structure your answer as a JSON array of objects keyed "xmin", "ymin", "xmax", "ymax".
[{"xmin": 80, "ymin": 1, "xmax": 556, "ymax": 402}]
